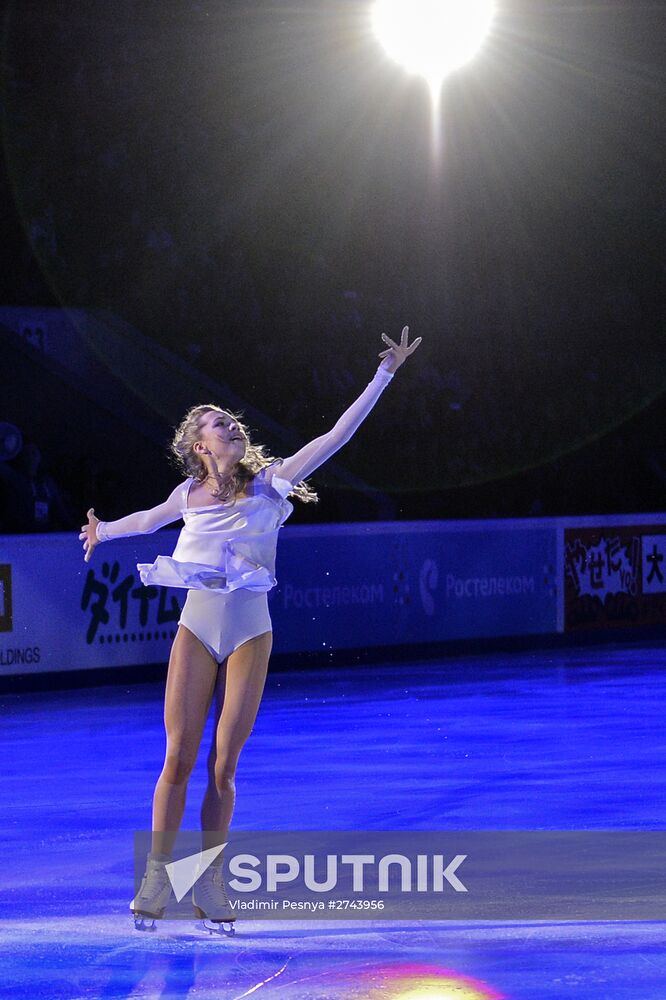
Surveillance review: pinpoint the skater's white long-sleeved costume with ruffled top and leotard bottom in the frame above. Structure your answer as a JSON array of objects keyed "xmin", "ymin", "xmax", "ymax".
[{"xmin": 97, "ymin": 365, "xmax": 393, "ymax": 662}]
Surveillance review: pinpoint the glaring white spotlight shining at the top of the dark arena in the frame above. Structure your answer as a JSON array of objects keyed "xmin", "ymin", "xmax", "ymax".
[{"xmin": 372, "ymin": 0, "xmax": 496, "ymax": 93}]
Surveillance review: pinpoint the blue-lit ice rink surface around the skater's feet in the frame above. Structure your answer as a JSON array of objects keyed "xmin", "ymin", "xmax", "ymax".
[{"xmin": 0, "ymin": 643, "xmax": 666, "ymax": 1000}]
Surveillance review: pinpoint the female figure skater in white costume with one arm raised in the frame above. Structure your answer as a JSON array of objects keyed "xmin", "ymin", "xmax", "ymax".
[{"xmin": 79, "ymin": 327, "xmax": 421, "ymax": 931}]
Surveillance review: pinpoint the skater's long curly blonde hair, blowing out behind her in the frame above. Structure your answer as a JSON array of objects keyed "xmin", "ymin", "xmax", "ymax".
[{"xmin": 170, "ymin": 403, "xmax": 319, "ymax": 503}]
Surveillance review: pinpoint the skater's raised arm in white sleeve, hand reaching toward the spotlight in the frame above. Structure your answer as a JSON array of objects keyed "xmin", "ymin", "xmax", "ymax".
[{"xmin": 274, "ymin": 327, "xmax": 421, "ymax": 484}]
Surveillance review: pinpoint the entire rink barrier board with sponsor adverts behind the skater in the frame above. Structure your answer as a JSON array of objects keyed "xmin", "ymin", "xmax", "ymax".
[{"xmin": 0, "ymin": 514, "xmax": 666, "ymax": 675}]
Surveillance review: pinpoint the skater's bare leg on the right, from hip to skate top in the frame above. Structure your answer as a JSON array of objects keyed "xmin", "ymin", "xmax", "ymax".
[{"xmin": 201, "ymin": 632, "xmax": 273, "ymax": 850}]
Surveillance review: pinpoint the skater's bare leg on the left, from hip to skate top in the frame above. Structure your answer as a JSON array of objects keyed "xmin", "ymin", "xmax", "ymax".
[{"xmin": 151, "ymin": 625, "xmax": 218, "ymax": 855}]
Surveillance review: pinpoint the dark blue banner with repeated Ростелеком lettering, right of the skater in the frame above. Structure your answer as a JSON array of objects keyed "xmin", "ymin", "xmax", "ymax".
[{"xmin": 270, "ymin": 521, "xmax": 557, "ymax": 652}]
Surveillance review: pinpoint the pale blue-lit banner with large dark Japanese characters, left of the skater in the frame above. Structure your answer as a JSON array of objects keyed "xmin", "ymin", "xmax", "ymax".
[{"xmin": 0, "ymin": 531, "xmax": 185, "ymax": 674}]
